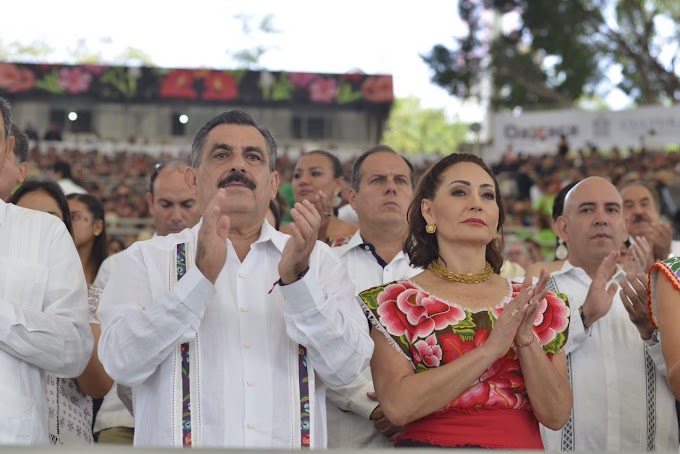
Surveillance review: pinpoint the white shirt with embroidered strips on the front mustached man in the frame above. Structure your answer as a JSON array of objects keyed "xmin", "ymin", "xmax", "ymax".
[{"xmin": 99, "ymin": 221, "xmax": 373, "ymax": 449}]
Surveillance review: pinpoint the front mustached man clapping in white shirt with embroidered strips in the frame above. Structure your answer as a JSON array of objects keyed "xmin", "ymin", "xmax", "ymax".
[{"xmin": 99, "ymin": 111, "xmax": 373, "ymax": 449}]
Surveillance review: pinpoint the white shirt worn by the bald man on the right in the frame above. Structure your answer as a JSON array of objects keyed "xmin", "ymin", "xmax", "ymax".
[{"xmin": 541, "ymin": 261, "xmax": 678, "ymax": 451}]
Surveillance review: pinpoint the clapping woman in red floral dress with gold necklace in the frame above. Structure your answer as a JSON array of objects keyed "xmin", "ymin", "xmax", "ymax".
[{"xmin": 360, "ymin": 154, "xmax": 572, "ymax": 449}]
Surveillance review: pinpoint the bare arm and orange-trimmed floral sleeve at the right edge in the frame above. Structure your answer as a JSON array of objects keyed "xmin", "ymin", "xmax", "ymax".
[{"xmin": 649, "ymin": 257, "xmax": 680, "ymax": 399}]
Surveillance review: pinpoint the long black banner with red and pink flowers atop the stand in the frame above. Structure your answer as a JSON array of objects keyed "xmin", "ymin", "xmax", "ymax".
[{"xmin": 0, "ymin": 62, "xmax": 394, "ymax": 105}]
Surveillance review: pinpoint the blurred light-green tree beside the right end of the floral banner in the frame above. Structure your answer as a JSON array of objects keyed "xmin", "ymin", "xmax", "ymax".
[{"xmin": 382, "ymin": 97, "xmax": 468, "ymax": 155}]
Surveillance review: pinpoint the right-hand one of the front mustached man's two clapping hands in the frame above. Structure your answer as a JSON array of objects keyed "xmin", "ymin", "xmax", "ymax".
[{"xmin": 279, "ymin": 200, "xmax": 321, "ymax": 284}]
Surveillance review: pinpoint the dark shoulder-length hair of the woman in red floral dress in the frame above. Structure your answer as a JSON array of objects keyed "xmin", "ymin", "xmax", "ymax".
[{"xmin": 404, "ymin": 153, "xmax": 505, "ymax": 274}]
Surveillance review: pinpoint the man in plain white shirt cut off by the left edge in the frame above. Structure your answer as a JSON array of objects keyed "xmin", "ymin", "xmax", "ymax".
[{"xmin": 0, "ymin": 97, "xmax": 94, "ymax": 445}]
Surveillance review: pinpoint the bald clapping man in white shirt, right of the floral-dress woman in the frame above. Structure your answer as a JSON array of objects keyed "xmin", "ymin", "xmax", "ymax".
[{"xmin": 541, "ymin": 177, "xmax": 678, "ymax": 451}]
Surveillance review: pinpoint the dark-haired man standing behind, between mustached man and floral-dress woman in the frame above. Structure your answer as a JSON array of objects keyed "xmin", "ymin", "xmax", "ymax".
[{"xmin": 327, "ymin": 145, "xmax": 422, "ymax": 448}]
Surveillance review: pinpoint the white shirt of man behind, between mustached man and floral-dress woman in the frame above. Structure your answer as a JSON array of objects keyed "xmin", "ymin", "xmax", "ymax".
[{"xmin": 327, "ymin": 231, "xmax": 423, "ymax": 448}]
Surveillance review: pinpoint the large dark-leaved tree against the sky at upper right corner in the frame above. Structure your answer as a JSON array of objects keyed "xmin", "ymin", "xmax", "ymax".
[{"xmin": 423, "ymin": 0, "xmax": 680, "ymax": 108}]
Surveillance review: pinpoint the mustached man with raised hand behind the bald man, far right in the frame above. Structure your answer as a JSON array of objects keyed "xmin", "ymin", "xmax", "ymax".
[{"xmin": 621, "ymin": 181, "xmax": 680, "ymax": 265}]
